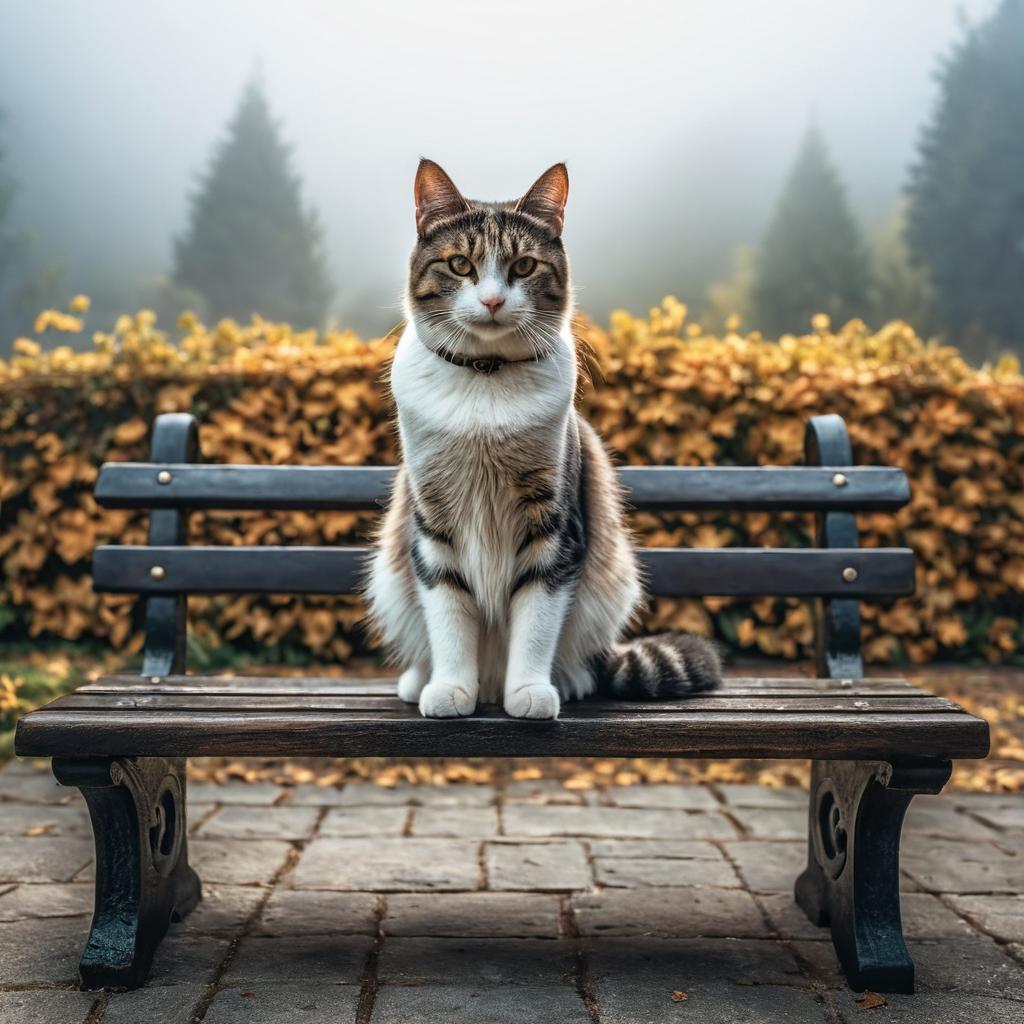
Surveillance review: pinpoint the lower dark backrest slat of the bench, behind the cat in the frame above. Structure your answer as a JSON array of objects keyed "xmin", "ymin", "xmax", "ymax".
[{"xmin": 92, "ymin": 545, "xmax": 914, "ymax": 598}]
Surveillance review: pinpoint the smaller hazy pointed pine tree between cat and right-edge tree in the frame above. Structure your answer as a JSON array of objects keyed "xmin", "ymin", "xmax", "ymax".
[{"xmin": 751, "ymin": 128, "xmax": 868, "ymax": 335}]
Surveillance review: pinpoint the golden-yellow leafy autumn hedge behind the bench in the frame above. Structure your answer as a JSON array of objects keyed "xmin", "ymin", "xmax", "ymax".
[{"xmin": 0, "ymin": 297, "xmax": 1024, "ymax": 662}]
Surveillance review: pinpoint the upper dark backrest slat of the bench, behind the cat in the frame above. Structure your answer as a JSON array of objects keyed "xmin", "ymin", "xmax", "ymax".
[{"xmin": 95, "ymin": 463, "xmax": 910, "ymax": 512}]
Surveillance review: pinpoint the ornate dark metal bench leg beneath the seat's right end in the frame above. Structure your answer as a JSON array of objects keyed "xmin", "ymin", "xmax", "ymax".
[{"xmin": 796, "ymin": 761, "xmax": 952, "ymax": 992}]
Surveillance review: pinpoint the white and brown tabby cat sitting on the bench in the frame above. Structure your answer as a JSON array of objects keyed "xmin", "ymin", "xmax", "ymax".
[{"xmin": 367, "ymin": 160, "xmax": 721, "ymax": 719}]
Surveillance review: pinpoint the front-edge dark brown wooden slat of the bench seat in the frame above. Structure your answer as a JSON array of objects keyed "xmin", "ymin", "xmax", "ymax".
[{"xmin": 17, "ymin": 706, "xmax": 988, "ymax": 761}]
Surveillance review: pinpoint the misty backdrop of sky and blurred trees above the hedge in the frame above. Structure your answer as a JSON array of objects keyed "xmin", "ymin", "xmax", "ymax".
[{"xmin": 0, "ymin": 0, "xmax": 1024, "ymax": 362}]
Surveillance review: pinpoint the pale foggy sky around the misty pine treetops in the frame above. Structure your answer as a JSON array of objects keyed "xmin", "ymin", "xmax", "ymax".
[{"xmin": 0, "ymin": 0, "xmax": 996, "ymax": 331}]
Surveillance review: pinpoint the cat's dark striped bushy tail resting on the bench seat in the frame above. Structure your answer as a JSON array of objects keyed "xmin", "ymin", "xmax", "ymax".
[{"xmin": 595, "ymin": 633, "xmax": 722, "ymax": 700}]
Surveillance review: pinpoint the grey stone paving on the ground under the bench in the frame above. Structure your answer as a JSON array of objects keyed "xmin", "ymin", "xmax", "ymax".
[{"xmin": 0, "ymin": 763, "xmax": 1024, "ymax": 1024}]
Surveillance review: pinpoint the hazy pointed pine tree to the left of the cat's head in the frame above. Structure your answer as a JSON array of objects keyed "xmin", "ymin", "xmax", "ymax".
[{"xmin": 174, "ymin": 80, "xmax": 331, "ymax": 328}]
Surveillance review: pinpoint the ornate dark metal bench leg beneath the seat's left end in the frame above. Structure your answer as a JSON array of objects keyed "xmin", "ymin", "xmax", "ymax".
[{"xmin": 53, "ymin": 758, "xmax": 201, "ymax": 988}]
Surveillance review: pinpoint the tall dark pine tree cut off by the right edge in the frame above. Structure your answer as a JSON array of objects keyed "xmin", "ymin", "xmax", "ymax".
[{"xmin": 908, "ymin": 0, "xmax": 1024, "ymax": 356}]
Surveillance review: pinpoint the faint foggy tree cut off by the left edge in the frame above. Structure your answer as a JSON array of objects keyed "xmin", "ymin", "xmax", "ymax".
[{"xmin": 0, "ymin": 110, "xmax": 60, "ymax": 346}]
